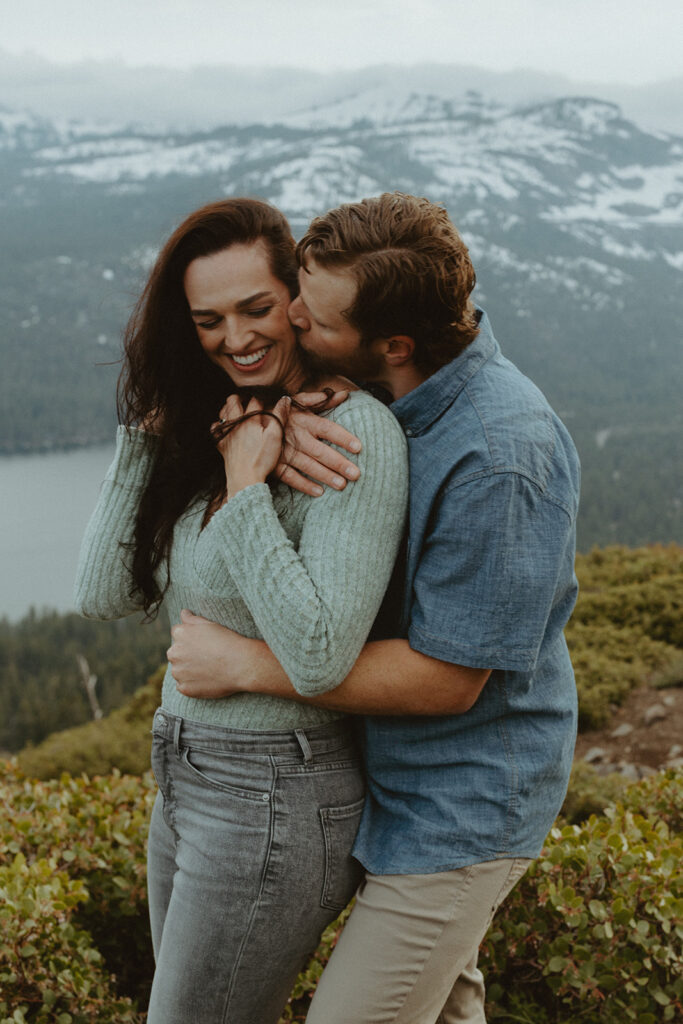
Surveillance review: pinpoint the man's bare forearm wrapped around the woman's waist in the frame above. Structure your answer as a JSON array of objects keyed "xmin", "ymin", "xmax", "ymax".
[{"xmin": 240, "ymin": 640, "xmax": 489, "ymax": 715}]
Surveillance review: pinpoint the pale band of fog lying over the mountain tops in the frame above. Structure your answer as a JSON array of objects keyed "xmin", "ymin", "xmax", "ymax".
[{"xmin": 0, "ymin": 48, "xmax": 683, "ymax": 133}]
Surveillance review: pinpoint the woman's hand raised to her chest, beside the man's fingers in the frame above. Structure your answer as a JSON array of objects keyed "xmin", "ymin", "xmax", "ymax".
[{"xmin": 218, "ymin": 395, "xmax": 291, "ymax": 500}]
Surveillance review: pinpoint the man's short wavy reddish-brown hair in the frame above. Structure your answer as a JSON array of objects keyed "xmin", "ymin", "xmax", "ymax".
[{"xmin": 297, "ymin": 193, "xmax": 478, "ymax": 373}]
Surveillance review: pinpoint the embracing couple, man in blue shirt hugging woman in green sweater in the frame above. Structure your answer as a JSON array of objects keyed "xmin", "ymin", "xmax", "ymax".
[{"xmin": 76, "ymin": 194, "xmax": 579, "ymax": 1024}]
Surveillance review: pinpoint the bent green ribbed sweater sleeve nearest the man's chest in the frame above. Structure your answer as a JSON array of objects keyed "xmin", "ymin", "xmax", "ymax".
[{"xmin": 202, "ymin": 394, "xmax": 408, "ymax": 696}]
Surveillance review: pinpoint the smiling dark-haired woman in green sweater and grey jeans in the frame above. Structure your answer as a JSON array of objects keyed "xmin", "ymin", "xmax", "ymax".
[{"xmin": 76, "ymin": 199, "xmax": 407, "ymax": 1024}]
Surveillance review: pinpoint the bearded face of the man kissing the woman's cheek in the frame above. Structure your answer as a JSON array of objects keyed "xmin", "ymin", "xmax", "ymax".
[{"xmin": 289, "ymin": 260, "xmax": 384, "ymax": 380}]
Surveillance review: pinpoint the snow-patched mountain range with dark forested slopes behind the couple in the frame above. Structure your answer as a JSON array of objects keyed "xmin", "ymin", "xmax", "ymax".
[{"xmin": 0, "ymin": 92, "xmax": 683, "ymax": 543}]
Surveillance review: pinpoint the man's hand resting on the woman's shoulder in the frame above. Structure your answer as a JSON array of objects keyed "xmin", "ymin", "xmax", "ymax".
[{"xmin": 276, "ymin": 391, "xmax": 361, "ymax": 498}]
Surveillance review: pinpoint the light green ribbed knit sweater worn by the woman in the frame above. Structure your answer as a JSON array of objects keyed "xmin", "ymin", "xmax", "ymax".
[{"xmin": 75, "ymin": 391, "xmax": 408, "ymax": 729}]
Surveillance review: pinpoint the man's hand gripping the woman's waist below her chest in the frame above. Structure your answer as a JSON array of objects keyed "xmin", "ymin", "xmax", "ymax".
[{"xmin": 166, "ymin": 608, "xmax": 261, "ymax": 699}]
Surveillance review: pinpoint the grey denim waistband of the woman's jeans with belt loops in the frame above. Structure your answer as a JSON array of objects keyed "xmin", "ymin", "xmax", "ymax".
[{"xmin": 152, "ymin": 708, "xmax": 355, "ymax": 761}]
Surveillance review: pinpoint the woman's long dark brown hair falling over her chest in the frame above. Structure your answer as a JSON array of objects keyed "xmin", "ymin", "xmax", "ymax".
[{"xmin": 117, "ymin": 199, "xmax": 297, "ymax": 615}]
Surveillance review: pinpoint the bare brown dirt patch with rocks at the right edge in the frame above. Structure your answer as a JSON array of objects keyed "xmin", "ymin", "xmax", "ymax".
[{"xmin": 575, "ymin": 687, "xmax": 683, "ymax": 774}]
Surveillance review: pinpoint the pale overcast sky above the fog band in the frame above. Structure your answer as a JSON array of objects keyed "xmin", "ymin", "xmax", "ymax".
[{"xmin": 5, "ymin": 0, "xmax": 683, "ymax": 85}]
